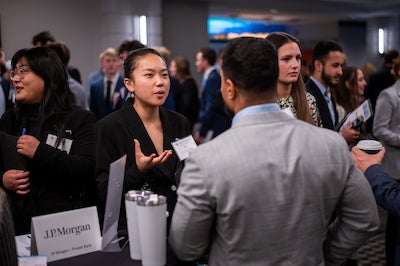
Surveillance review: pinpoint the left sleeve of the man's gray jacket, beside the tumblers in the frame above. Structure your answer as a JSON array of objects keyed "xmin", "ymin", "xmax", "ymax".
[{"xmin": 169, "ymin": 153, "xmax": 214, "ymax": 260}]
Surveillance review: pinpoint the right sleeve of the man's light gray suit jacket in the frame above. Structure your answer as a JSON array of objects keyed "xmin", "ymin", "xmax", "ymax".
[{"xmin": 324, "ymin": 164, "xmax": 379, "ymax": 265}]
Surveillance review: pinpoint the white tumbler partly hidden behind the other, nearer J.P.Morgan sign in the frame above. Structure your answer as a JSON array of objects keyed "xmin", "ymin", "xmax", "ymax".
[{"xmin": 125, "ymin": 190, "xmax": 152, "ymax": 260}]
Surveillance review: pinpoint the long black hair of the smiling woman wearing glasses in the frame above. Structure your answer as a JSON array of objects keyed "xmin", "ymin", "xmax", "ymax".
[{"xmin": 11, "ymin": 47, "xmax": 75, "ymax": 138}]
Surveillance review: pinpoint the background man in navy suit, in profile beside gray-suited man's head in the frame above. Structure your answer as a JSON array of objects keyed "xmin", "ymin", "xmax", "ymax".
[{"xmin": 196, "ymin": 47, "xmax": 231, "ymax": 143}]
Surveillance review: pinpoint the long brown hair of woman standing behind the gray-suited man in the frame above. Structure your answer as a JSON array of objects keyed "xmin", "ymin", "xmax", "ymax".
[{"xmin": 265, "ymin": 32, "xmax": 315, "ymax": 125}]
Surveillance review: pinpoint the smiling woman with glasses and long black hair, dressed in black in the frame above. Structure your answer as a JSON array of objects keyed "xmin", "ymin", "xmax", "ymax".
[{"xmin": 0, "ymin": 47, "xmax": 96, "ymax": 234}]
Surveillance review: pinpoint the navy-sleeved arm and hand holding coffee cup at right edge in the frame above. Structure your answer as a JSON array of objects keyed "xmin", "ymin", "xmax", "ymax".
[{"xmin": 352, "ymin": 147, "xmax": 400, "ymax": 265}]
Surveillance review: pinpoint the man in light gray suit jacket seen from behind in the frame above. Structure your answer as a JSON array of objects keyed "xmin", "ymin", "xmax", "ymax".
[{"xmin": 169, "ymin": 37, "xmax": 379, "ymax": 266}]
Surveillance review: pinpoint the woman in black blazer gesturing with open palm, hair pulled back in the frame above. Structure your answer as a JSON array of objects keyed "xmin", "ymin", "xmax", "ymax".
[{"xmin": 96, "ymin": 48, "xmax": 190, "ymax": 235}]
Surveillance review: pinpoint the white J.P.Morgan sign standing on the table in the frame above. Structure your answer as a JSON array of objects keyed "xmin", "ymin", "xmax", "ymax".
[{"xmin": 31, "ymin": 207, "xmax": 101, "ymax": 262}]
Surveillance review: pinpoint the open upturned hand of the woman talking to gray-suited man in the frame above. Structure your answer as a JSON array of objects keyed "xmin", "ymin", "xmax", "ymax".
[{"xmin": 134, "ymin": 139, "xmax": 172, "ymax": 174}]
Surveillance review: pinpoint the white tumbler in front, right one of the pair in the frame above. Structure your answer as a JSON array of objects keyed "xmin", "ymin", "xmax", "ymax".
[{"xmin": 136, "ymin": 194, "xmax": 167, "ymax": 266}]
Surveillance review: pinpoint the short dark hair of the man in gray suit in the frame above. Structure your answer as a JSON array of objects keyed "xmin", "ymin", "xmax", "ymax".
[{"xmin": 222, "ymin": 37, "xmax": 279, "ymax": 93}]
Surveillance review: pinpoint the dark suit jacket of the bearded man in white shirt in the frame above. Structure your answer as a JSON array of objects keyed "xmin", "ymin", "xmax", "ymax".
[{"xmin": 306, "ymin": 79, "xmax": 339, "ymax": 130}]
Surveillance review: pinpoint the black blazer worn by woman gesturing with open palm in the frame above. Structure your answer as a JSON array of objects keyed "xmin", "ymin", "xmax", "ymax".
[{"xmin": 96, "ymin": 98, "xmax": 190, "ymax": 234}]
